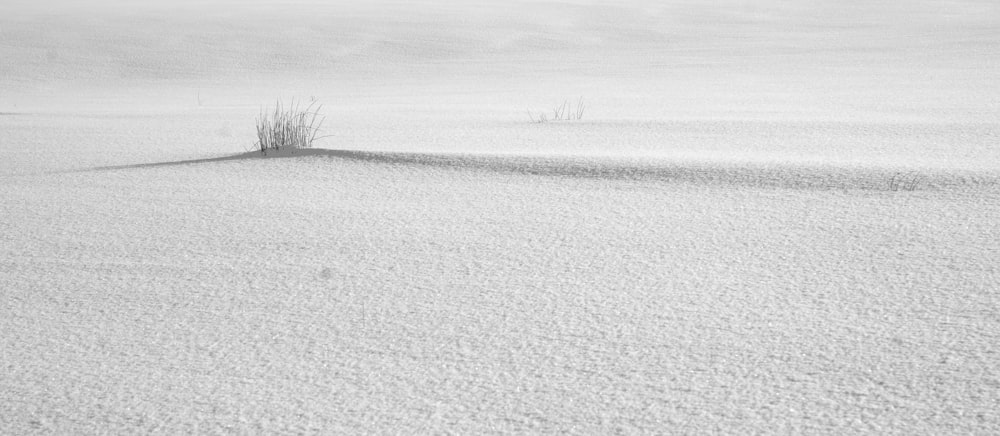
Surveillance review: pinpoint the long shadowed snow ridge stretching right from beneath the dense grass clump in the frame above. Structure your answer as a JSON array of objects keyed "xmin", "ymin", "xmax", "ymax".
[{"xmin": 86, "ymin": 148, "xmax": 1000, "ymax": 191}]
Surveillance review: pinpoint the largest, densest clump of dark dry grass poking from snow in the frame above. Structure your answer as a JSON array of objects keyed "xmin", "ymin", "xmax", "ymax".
[{"xmin": 255, "ymin": 99, "xmax": 325, "ymax": 155}]
